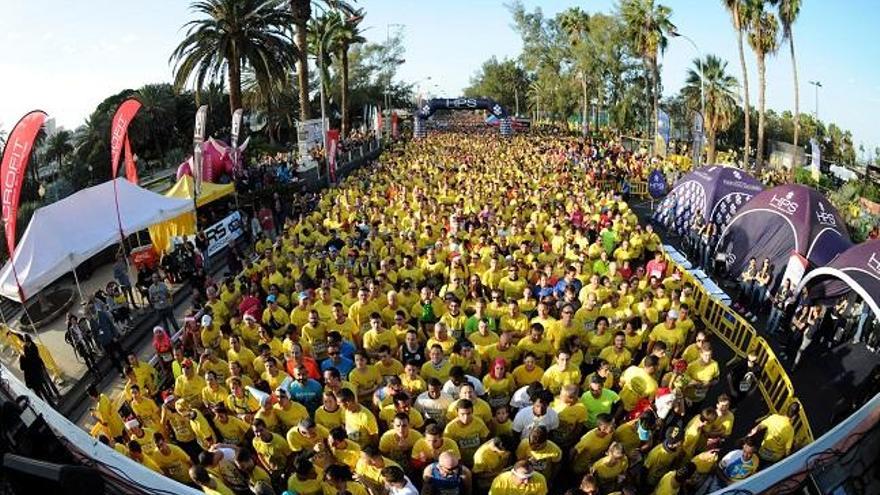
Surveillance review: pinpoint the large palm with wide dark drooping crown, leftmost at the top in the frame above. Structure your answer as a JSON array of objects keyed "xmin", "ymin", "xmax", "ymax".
[{"xmin": 170, "ymin": 0, "xmax": 296, "ymax": 114}]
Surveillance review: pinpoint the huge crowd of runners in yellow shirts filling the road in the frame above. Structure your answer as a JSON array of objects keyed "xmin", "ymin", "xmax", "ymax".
[{"xmin": 89, "ymin": 133, "xmax": 797, "ymax": 495}]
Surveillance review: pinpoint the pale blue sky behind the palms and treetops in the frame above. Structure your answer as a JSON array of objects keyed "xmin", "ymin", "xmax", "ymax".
[{"xmin": 0, "ymin": 0, "xmax": 880, "ymax": 155}]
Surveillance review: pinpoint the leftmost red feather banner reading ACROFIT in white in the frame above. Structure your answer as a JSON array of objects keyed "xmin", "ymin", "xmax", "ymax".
[{"xmin": 0, "ymin": 110, "xmax": 46, "ymax": 260}]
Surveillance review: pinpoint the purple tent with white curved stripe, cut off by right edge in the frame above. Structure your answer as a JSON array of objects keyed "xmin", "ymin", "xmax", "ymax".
[{"xmin": 798, "ymin": 240, "xmax": 880, "ymax": 319}]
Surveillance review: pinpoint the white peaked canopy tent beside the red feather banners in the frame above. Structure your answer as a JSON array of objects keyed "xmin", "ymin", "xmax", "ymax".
[{"xmin": 0, "ymin": 178, "xmax": 193, "ymax": 301}]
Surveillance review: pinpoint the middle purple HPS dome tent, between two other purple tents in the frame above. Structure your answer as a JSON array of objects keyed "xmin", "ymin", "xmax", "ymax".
[{"xmin": 718, "ymin": 184, "xmax": 852, "ymax": 284}]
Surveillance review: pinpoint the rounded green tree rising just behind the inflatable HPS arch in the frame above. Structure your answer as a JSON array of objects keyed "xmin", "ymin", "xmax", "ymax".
[{"xmin": 464, "ymin": 57, "xmax": 530, "ymax": 113}]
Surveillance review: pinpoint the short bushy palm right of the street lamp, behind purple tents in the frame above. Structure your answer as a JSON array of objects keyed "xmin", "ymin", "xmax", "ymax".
[{"xmin": 681, "ymin": 55, "xmax": 739, "ymax": 164}]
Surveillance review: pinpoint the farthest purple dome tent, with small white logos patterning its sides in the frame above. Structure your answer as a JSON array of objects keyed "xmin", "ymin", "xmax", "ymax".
[{"xmin": 654, "ymin": 165, "xmax": 764, "ymax": 235}]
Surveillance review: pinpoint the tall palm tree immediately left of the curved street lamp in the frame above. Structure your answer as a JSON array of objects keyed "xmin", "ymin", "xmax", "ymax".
[{"xmin": 620, "ymin": 0, "xmax": 675, "ymax": 143}]
